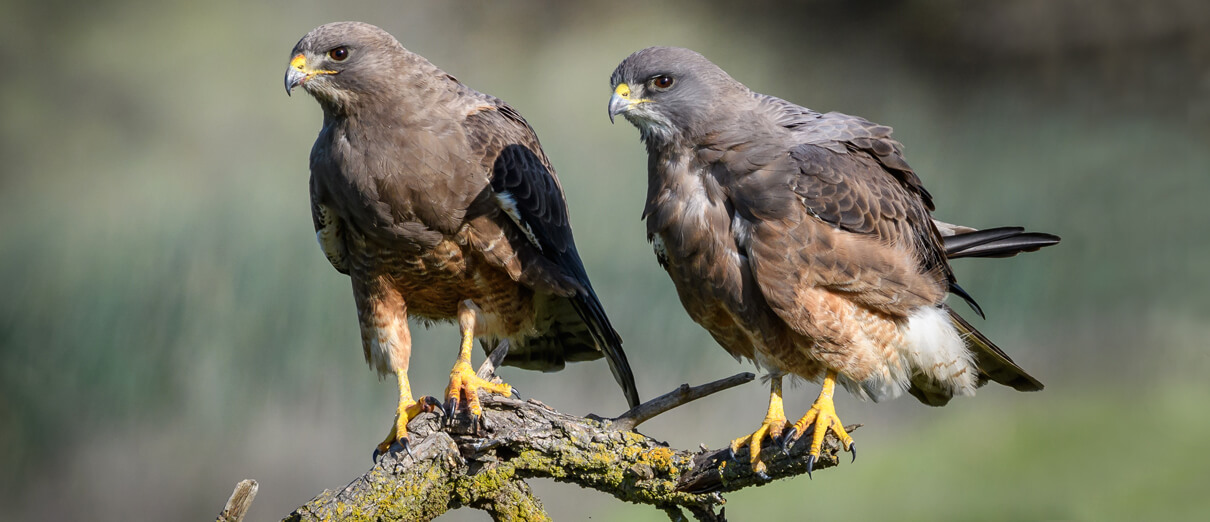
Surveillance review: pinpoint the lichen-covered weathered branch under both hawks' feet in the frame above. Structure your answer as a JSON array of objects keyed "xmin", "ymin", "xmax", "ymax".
[{"xmin": 278, "ymin": 374, "xmax": 857, "ymax": 521}]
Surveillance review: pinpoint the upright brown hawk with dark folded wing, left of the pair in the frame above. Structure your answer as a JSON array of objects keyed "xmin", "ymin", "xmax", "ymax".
[{"xmin": 286, "ymin": 22, "xmax": 639, "ymax": 452}]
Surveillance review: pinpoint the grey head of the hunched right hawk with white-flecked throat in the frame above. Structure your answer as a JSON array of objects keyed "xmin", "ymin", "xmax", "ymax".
[{"xmin": 609, "ymin": 47, "xmax": 750, "ymax": 145}]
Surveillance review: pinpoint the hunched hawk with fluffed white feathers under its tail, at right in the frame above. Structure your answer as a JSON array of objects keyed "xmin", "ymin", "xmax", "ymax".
[{"xmin": 609, "ymin": 47, "xmax": 1059, "ymax": 472}]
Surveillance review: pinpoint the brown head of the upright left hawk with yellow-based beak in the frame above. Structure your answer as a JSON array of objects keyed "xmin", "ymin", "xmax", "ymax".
[{"xmin": 286, "ymin": 22, "xmax": 407, "ymax": 110}]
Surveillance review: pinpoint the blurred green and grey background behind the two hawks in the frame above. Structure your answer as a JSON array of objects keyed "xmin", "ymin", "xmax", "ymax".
[{"xmin": 0, "ymin": 0, "xmax": 1210, "ymax": 521}]
